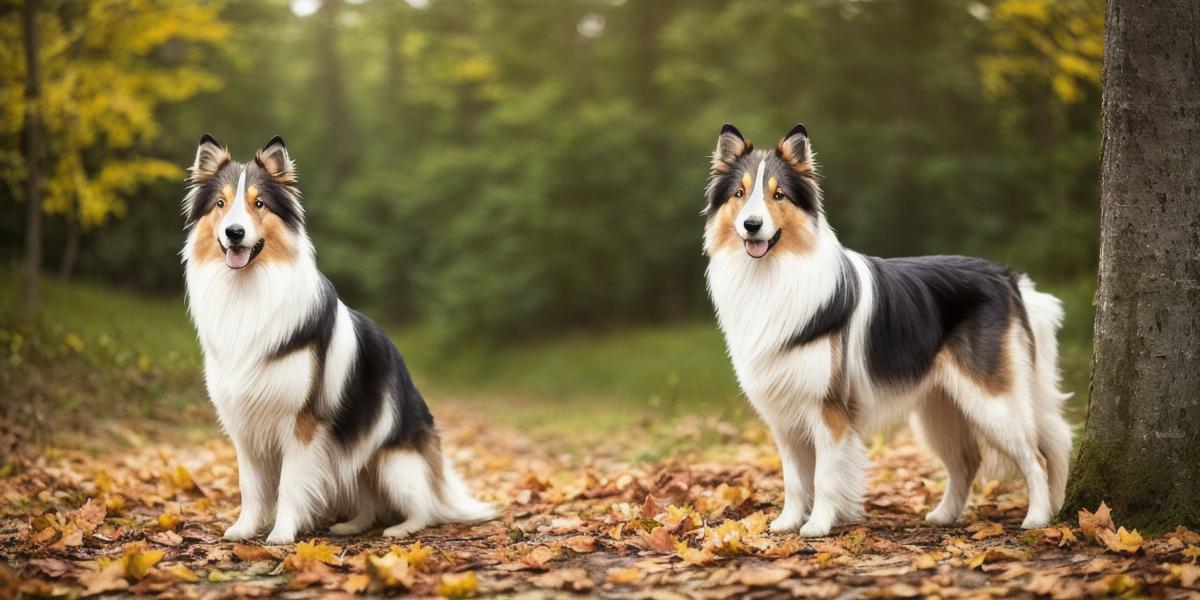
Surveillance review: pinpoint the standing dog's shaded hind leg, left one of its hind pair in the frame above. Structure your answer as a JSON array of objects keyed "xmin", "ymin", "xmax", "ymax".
[{"xmin": 912, "ymin": 388, "xmax": 980, "ymax": 524}]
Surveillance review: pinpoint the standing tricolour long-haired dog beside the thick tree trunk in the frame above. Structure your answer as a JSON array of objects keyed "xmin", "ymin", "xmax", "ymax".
[{"xmin": 704, "ymin": 124, "xmax": 1070, "ymax": 536}]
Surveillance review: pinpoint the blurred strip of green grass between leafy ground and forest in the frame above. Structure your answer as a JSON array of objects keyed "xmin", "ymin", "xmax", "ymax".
[{"xmin": 0, "ymin": 270, "xmax": 1094, "ymax": 431}]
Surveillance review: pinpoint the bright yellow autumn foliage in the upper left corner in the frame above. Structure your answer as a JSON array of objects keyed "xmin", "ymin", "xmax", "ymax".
[{"xmin": 0, "ymin": 0, "xmax": 230, "ymax": 229}]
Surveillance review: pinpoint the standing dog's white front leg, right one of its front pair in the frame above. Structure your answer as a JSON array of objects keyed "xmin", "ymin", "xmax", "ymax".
[{"xmin": 800, "ymin": 420, "xmax": 868, "ymax": 538}]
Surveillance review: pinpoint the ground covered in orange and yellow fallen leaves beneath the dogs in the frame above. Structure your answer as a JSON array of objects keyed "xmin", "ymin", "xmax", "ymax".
[{"xmin": 0, "ymin": 407, "xmax": 1200, "ymax": 599}]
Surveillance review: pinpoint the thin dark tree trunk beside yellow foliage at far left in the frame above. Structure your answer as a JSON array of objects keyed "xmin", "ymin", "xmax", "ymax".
[{"xmin": 23, "ymin": 0, "xmax": 42, "ymax": 317}]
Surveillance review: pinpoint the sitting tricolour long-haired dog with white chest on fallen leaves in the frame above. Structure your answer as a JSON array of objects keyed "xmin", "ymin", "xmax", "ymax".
[{"xmin": 182, "ymin": 134, "xmax": 493, "ymax": 544}]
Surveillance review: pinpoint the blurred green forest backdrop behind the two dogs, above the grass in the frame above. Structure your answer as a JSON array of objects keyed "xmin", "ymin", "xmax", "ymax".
[{"xmin": 0, "ymin": 0, "xmax": 1103, "ymax": 350}]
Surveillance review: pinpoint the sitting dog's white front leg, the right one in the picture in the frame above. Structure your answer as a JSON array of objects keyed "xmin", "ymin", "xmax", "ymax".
[{"xmin": 266, "ymin": 443, "xmax": 330, "ymax": 544}]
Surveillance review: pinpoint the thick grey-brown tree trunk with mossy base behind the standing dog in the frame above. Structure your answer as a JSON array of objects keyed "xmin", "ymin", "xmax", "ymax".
[{"xmin": 1064, "ymin": 0, "xmax": 1200, "ymax": 533}]
